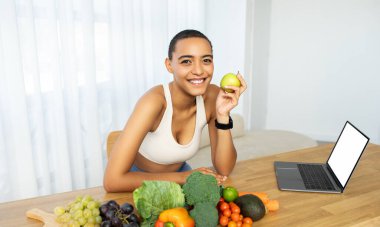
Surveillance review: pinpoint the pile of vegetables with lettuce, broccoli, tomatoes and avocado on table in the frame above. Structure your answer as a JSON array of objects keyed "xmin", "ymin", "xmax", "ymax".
[{"xmin": 133, "ymin": 172, "xmax": 279, "ymax": 227}]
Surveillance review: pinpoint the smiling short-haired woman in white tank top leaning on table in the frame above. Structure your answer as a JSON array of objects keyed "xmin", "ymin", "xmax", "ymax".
[{"xmin": 104, "ymin": 30, "xmax": 246, "ymax": 192}]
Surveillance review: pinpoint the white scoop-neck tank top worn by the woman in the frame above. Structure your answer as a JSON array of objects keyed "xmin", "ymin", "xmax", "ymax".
[{"xmin": 139, "ymin": 84, "xmax": 207, "ymax": 165}]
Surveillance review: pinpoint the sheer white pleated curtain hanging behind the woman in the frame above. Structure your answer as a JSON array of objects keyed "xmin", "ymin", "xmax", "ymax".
[{"xmin": 0, "ymin": 0, "xmax": 206, "ymax": 202}]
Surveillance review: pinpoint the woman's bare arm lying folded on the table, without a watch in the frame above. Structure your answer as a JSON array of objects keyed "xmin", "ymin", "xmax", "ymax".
[{"xmin": 103, "ymin": 88, "xmax": 190, "ymax": 192}]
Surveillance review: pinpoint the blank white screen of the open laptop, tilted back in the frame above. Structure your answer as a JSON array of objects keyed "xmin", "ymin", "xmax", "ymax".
[{"xmin": 327, "ymin": 121, "xmax": 369, "ymax": 188}]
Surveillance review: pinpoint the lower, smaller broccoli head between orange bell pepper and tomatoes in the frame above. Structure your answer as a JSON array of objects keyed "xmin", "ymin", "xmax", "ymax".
[{"xmin": 190, "ymin": 202, "xmax": 219, "ymax": 227}]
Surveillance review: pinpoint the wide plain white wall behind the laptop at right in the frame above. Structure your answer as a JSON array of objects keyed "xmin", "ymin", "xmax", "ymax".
[{"xmin": 252, "ymin": 0, "xmax": 380, "ymax": 144}]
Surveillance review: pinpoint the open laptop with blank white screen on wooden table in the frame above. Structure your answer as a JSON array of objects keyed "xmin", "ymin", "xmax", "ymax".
[{"xmin": 274, "ymin": 121, "xmax": 369, "ymax": 193}]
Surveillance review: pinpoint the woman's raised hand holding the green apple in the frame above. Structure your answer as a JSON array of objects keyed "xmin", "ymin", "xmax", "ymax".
[{"xmin": 216, "ymin": 72, "xmax": 247, "ymax": 117}]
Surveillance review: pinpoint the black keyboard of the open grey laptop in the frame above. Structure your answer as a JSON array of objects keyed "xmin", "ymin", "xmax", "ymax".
[{"xmin": 297, "ymin": 164, "xmax": 334, "ymax": 191}]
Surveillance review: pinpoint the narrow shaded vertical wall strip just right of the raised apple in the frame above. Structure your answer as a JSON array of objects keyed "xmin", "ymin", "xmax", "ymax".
[{"xmin": 245, "ymin": 0, "xmax": 271, "ymax": 129}]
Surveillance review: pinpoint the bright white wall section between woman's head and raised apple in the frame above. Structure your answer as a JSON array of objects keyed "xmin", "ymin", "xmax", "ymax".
[{"xmin": 206, "ymin": 0, "xmax": 246, "ymax": 114}]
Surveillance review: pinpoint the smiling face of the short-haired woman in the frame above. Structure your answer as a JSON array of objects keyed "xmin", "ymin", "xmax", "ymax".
[{"xmin": 165, "ymin": 38, "xmax": 214, "ymax": 96}]
